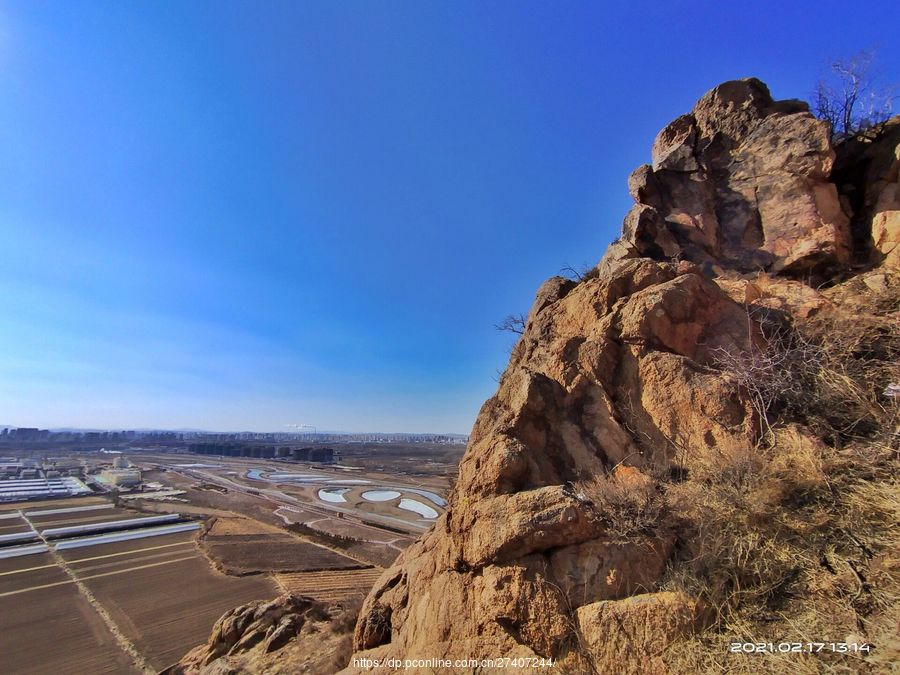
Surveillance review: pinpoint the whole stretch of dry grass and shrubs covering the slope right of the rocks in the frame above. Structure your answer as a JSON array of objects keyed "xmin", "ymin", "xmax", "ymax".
[{"xmin": 658, "ymin": 284, "xmax": 900, "ymax": 673}]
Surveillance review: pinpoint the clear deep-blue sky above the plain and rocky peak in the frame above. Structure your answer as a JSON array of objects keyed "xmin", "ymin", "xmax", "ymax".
[{"xmin": 0, "ymin": 0, "xmax": 900, "ymax": 433}]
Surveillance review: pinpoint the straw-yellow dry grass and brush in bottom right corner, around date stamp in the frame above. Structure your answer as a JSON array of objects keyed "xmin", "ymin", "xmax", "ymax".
[{"xmin": 665, "ymin": 426, "xmax": 900, "ymax": 673}]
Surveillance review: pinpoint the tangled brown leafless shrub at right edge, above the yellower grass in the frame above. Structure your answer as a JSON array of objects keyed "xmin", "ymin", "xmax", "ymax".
[{"xmin": 713, "ymin": 296, "xmax": 900, "ymax": 444}]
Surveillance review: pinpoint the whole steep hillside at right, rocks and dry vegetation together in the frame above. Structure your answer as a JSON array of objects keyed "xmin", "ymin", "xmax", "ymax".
[{"xmin": 172, "ymin": 79, "xmax": 900, "ymax": 673}]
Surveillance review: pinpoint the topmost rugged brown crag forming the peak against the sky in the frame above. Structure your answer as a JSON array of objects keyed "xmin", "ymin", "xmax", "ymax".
[{"xmin": 624, "ymin": 79, "xmax": 851, "ymax": 276}]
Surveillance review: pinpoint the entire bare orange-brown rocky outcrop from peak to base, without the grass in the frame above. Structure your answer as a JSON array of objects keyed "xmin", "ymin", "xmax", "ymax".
[{"xmin": 348, "ymin": 79, "xmax": 897, "ymax": 672}]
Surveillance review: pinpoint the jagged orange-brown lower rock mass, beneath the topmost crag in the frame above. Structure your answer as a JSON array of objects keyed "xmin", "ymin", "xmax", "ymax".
[{"xmin": 348, "ymin": 259, "xmax": 758, "ymax": 672}]
